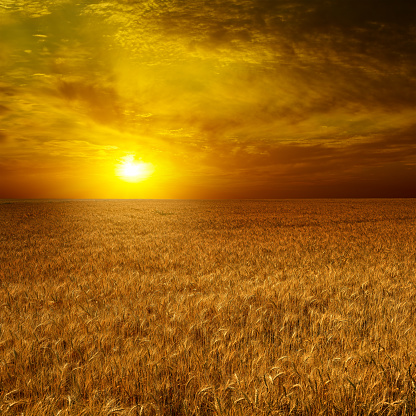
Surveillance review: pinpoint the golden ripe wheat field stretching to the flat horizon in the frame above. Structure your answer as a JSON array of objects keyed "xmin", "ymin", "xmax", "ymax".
[{"xmin": 0, "ymin": 199, "xmax": 416, "ymax": 416}]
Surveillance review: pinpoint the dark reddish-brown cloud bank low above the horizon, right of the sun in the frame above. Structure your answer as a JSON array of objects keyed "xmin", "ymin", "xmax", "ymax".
[{"xmin": 192, "ymin": 125, "xmax": 416, "ymax": 197}]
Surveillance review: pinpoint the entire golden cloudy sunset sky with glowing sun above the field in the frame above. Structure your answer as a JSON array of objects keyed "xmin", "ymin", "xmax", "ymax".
[{"xmin": 0, "ymin": 0, "xmax": 416, "ymax": 199}]
